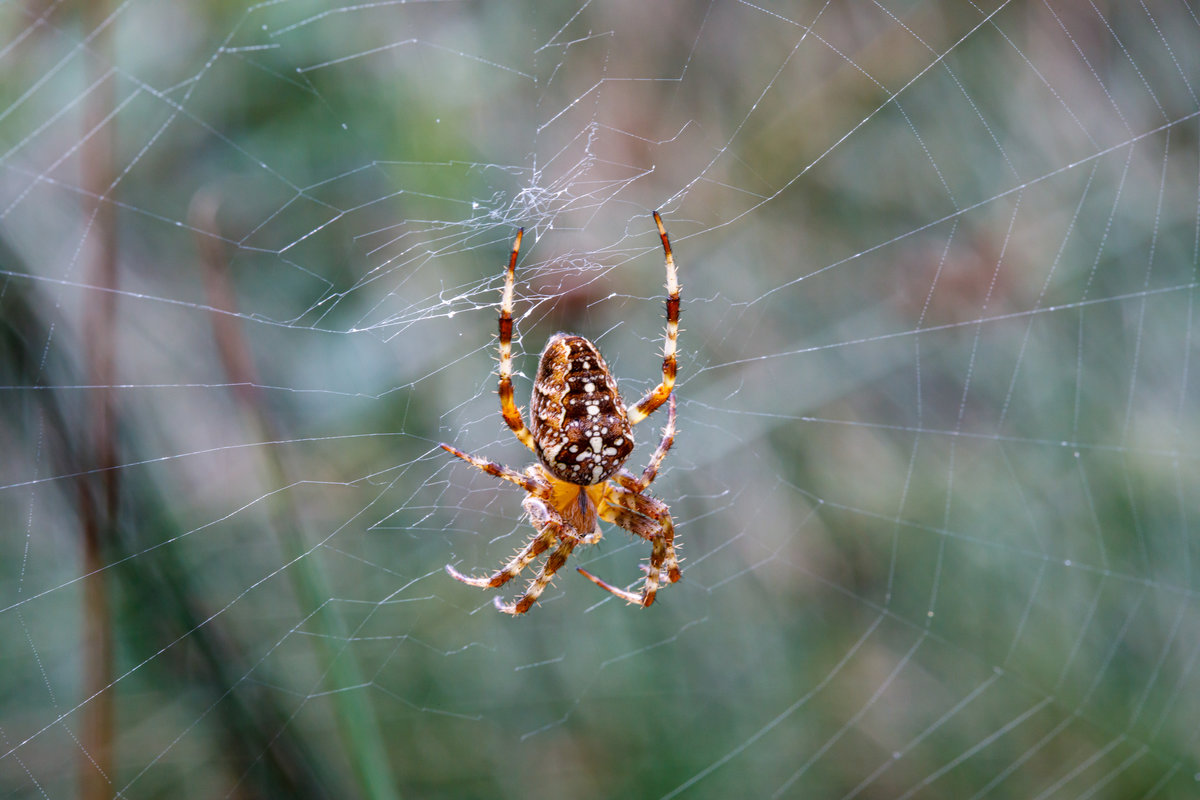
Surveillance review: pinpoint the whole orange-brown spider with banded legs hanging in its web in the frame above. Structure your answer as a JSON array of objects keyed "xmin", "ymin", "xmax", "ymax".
[{"xmin": 442, "ymin": 211, "xmax": 680, "ymax": 614}]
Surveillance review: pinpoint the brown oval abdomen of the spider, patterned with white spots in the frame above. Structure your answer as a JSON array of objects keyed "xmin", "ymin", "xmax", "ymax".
[{"xmin": 529, "ymin": 333, "xmax": 634, "ymax": 486}]
